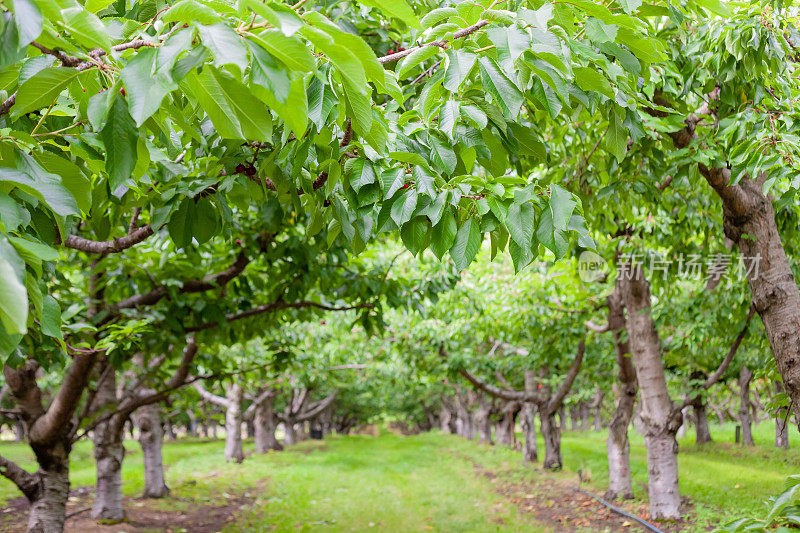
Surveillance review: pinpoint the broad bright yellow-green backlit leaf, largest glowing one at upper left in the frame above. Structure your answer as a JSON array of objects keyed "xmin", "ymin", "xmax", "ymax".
[{"xmin": 180, "ymin": 65, "xmax": 272, "ymax": 141}]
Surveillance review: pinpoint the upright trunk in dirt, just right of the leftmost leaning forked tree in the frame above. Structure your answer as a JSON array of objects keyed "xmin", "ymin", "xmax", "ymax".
[{"xmin": 92, "ymin": 367, "xmax": 125, "ymax": 522}]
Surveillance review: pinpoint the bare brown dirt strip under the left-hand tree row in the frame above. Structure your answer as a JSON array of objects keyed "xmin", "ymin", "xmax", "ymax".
[{"xmin": 0, "ymin": 488, "xmax": 252, "ymax": 533}]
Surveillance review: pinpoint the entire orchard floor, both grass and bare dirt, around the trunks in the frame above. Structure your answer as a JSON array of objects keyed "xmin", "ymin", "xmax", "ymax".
[{"xmin": 0, "ymin": 428, "xmax": 800, "ymax": 533}]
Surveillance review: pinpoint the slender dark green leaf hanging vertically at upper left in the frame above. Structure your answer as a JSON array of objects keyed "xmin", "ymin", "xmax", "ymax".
[{"xmin": 100, "ymin": 98, "xmax": 139, "ymax": 193}]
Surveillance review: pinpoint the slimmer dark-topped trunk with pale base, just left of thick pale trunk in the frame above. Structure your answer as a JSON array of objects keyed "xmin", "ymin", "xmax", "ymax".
[{"xmin": 605, "ymin": 281, "xmax": 639, "ymax": 500}]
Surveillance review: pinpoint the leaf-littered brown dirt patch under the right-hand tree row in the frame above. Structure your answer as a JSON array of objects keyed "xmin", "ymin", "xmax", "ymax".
[{"xmin": 473, "ymin": 463, "xmax": 693, "ymax": 533}]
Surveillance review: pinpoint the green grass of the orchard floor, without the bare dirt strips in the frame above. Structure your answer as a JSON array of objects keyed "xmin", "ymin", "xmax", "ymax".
[{"xmin": 0, "ymin": 422, "xmax": 800, "ymax": 531}]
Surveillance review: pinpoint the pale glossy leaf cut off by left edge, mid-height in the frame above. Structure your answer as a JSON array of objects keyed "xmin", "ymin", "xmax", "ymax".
[{"xmin": 0, "ymin": 239, "xmax": 28, "ymax": 335}]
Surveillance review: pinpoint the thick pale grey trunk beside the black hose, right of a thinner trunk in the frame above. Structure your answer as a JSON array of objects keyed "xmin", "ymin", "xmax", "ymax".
[{"xmin": 620, "ymin": 265, "xmax": 681, "ymax": 520}]
